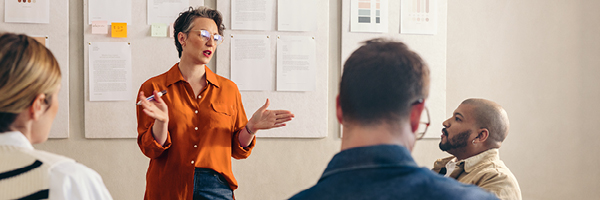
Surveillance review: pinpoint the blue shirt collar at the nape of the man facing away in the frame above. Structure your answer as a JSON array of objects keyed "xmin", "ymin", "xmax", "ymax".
[{"xmin": 321, "ymin": 145, "xmax": 419, "ymax": 180}]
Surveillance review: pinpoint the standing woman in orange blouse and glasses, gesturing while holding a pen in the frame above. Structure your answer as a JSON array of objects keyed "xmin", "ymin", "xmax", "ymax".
[{"xmin": 137, "ymin": 7, "xmax": 294, "ymax": 199}]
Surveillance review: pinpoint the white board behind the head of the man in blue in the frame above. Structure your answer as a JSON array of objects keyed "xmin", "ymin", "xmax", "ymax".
[{"xmin": 340, "ymin": 0, "xmax": 448, "ymax": 138}]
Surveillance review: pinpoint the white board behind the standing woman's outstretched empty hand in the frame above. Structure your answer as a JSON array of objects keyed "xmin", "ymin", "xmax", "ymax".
[{"xmin": 216, "ymin": 0, "xmax": 329, "ymax": 138}]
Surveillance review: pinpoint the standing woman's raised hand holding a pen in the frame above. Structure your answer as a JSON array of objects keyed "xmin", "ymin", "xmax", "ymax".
[{"xmin": 139, "ymin": 91, "xmax": 169, "ymax": 145}]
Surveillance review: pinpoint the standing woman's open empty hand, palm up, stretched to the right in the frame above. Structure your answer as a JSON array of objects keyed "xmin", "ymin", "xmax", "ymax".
[{"xmin": 246, "ymin": 99, "xmax": 294, "ymax": 134}]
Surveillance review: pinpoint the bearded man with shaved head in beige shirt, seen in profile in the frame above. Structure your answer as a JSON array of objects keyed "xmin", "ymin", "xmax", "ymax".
[{"xmin": 433, "ymin": 99, "xmax": 521, "ymax": 200}]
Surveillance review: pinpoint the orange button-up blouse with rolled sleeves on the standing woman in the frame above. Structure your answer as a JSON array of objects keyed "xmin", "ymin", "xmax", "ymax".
[{"xmin": 137, "ymin": 64, "xmax": 256, "ymax": 200}]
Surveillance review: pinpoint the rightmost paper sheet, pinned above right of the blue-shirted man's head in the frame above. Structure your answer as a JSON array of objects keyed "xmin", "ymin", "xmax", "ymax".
[{"xmin": 400, "ymin": 0, "xmax": 438, "ymax": 35}]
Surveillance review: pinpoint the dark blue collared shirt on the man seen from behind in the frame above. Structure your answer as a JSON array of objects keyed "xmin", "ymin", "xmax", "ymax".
[{"xmin": 291, "ymin": 145, "xmax": 498, "ymax": 200}]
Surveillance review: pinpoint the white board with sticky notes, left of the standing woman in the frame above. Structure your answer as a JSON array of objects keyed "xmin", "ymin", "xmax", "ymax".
[{"xmin": 82, "ymin": 0, "xmax": 204, "ymax": 138}]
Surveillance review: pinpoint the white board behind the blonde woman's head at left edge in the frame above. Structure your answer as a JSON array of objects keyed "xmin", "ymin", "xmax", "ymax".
[{"xmin": 0, "ymin": 0, "xmax": 69, "ymax": 138}]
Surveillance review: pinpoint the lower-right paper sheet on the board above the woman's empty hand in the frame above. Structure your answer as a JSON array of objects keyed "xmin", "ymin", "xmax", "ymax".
[{"xmin": 277, "ymin": 36, "xmax": 317, "ymax": 91}]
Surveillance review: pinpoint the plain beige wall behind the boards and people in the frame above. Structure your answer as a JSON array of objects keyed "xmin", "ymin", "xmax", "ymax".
[{"xmin": 31, "ymin": 0, "xmax": 600, "ymax": 200}]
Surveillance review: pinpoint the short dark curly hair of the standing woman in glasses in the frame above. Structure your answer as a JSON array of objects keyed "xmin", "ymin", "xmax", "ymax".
[{"xmin": 173, "ymin": 6, "xmax": 225, "ymax": 58}]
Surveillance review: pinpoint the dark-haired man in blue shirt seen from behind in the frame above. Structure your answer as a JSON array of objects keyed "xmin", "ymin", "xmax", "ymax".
[{"xmin": 291, "ymin": 39, "xmax": 497, "ymax": 200}]
